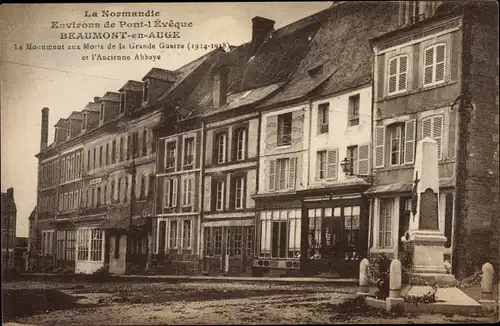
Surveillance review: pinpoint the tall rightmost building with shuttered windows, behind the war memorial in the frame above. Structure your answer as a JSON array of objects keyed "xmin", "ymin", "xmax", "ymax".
[{"xmin": 367, "ymin": 1, "xmax": 498, "ymax": 276}]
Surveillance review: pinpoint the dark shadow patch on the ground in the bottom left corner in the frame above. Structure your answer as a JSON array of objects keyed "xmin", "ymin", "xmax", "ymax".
[{"xmin": 2, "ymin": 289, "xmax": 100, "ymax": 323}]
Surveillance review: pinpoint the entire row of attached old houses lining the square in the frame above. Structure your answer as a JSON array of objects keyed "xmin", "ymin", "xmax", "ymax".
[{"xmin": 30, "ymin": 1, "xmax": 499, "ymax": 275}]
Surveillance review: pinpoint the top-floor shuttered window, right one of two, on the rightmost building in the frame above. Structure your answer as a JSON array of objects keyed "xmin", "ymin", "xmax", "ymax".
[{"xmin": 424, "ymin": 44, "xmax": 446, "ymax": 86}]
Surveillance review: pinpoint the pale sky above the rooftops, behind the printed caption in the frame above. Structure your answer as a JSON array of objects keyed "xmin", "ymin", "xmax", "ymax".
[{"xmin": 0, "ymin": 2, "xmax": 331, "ymax": 236}]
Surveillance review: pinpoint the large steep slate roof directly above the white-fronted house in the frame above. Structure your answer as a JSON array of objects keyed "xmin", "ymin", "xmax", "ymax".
[{"xmin": 262, "ymin": 1, "xmax": 398, "ymax": 106}]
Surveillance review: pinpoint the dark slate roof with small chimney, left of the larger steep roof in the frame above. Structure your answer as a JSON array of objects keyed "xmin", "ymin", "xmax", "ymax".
[{"xmin": 176, "ymin": 8, "xmax": 332, "ymax": 116}]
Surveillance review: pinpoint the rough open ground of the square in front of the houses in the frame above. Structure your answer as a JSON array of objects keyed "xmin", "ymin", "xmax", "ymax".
[{"xmin": 2, "ymin": 281, "xmax": 497, "ymax": 325}]
